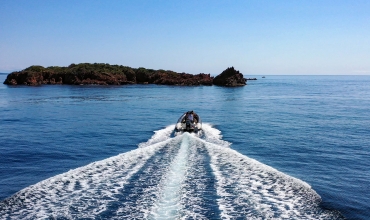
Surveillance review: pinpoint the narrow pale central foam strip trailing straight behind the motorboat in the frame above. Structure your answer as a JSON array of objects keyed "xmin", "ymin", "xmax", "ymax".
[{"xmin": 152, "ymin": 133, "xmax": 189, "ymax": 219}]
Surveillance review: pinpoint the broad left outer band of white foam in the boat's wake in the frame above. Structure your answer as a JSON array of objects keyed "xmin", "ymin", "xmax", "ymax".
[{"xmin": 0, "ymin": 141, "xmax": 168, "ymax": 219}]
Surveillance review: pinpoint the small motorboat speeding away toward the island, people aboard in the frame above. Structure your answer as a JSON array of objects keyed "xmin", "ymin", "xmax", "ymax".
[{"xmin": 175, "ymin": 111, "xmax": 202, "ymax": 132}]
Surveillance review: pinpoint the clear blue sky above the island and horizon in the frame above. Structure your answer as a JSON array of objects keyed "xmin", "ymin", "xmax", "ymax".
[{"xmin": 0, "ymin": 0, "xmax": 370, "ymax": 75}]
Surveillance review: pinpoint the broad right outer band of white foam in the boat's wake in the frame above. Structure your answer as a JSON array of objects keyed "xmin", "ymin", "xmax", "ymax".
[{"xmin": 205, "ymin": 143, "xmax": 340, "ymax": 219}]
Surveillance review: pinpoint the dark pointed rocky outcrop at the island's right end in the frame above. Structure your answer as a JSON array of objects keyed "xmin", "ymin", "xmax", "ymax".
[{"xmin": 213, "ymin": 67, "xmax": 247, "ymax": 87}]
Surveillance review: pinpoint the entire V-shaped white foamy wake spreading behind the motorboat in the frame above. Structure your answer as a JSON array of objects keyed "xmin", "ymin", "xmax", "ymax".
[{"xmin": 0, "ymin": 124, "xmax": 342, "ymax": 219}]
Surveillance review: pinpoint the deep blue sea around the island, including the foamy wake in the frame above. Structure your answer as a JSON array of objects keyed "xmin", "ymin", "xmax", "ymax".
[{"xmin": 0, "ymin": 74, "xmax": 370, "ymax": 219}]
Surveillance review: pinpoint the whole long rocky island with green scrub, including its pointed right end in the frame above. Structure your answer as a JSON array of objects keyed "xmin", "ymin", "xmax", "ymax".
[{"xmin": 4, "ymin": 63, "xmax": 247, "ymax": 87}]
